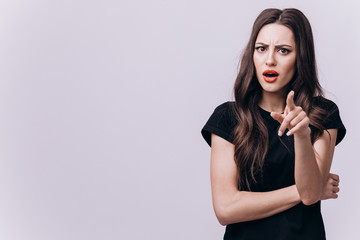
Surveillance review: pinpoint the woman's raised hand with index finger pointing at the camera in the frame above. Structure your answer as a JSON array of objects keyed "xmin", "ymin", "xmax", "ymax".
[{"xmin": 271, "ymin": 91, "xmax": 310, "ymax": 136}]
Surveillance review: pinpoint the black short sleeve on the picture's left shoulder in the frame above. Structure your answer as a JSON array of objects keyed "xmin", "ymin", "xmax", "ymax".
[{"xmin": 201, "ymin": 102, "xmax": 236, "ymax": 147}]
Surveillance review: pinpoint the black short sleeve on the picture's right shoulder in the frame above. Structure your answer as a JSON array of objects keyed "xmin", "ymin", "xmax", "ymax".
[{"xmin": 320, "ymin": 99, "xmax": 346, "ymax": 145}]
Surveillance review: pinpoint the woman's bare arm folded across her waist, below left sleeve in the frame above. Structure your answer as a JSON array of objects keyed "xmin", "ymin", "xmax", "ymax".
[{"xmin": 210, "ymin": 134, "xmax": 301, "ymax": 225}]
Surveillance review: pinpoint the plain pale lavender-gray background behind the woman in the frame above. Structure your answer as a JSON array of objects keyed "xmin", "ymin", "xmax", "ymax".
[{"xmin": 0, "ymin": 0, "xmax": 360, "ymax": 240}]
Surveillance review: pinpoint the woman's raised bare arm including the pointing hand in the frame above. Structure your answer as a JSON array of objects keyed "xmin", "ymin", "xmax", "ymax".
[{"xmin": 271, "ymin": 91, "xmax": 337, "ymax": 205}]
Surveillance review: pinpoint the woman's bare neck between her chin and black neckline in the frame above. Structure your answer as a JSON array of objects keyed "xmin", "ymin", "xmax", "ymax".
[{"xmin": 259, "ymin": 91, "xmax": 285, "ymax": 113}]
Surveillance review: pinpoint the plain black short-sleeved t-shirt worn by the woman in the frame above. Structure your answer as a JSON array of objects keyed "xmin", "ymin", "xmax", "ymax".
[{"xmin": 201, "ymin": 98, "xmax": 346, "ymax": 240}]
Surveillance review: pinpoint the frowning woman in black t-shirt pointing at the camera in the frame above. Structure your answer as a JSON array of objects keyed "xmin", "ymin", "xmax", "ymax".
[{"xmin": 202, "ymin": 9, "xmax": 346, "ymax": 240}]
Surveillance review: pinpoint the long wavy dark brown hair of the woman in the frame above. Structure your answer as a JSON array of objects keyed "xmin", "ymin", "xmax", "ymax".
[{"xmin": 233, "ymin": 8, "xmax": 327, "ymax": 190}]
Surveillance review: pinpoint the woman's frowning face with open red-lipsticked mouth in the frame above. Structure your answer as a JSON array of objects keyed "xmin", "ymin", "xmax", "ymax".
[{"xmin": 253, "ymin": 23, "xmax": 296, "ymax": 94}]
